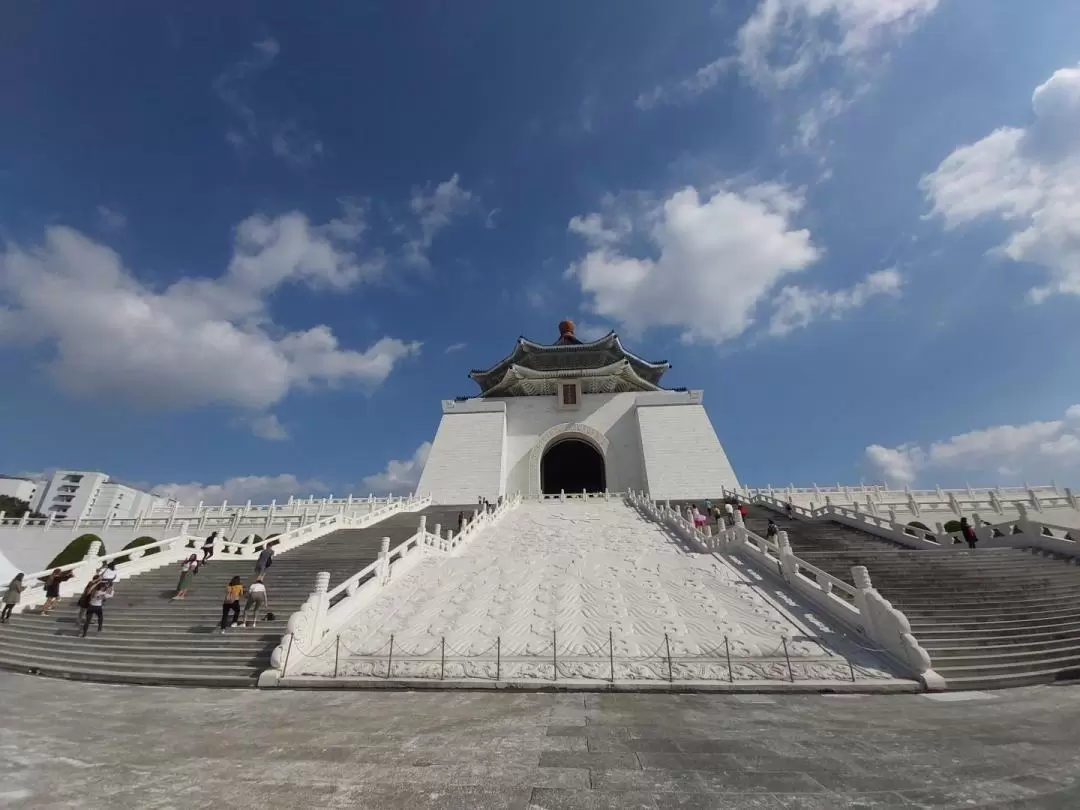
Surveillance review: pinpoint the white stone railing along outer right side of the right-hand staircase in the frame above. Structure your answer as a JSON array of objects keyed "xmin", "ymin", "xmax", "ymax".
[{"xmin": 747, "ymin": 495, "xmax": 1080, "ymax": 562}]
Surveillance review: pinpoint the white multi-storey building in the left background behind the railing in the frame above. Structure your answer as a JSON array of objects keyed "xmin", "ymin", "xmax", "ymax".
[{"xmin": 35, "ymin": 470, "xmax": 176, "ymax": 521}]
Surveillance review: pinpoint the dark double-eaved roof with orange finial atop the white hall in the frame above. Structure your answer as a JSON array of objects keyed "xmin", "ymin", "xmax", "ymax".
[{"xmin": 469, "ymin": 322, "xmax": 671, "ymax": 396}]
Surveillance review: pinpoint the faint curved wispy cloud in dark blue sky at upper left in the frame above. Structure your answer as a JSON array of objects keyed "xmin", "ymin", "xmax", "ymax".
[{"xmin": 214, "ymin": 37, "xmax": 323, "ymax": 166}]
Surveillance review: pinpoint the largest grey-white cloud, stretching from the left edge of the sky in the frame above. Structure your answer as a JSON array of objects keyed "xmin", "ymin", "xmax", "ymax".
[{"xmin": 0, "ymin": 212, "xmax": 420, "ymax": 419}]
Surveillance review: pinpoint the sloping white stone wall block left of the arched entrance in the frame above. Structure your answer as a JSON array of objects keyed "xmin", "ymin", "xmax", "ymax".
[{"xmin": 417, "ymin": 400, "xmax": 507, "ymax": 503}]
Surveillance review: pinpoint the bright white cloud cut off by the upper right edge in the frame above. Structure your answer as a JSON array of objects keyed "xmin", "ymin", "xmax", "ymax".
[{"xmin": 920, "ymin": 67, "xmax": 1080, "ymax": 302}]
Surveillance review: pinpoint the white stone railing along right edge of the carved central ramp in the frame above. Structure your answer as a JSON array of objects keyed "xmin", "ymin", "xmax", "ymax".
[{"xmin": 627, "ymin": 492, "xmax": 945, "ymax": 690}]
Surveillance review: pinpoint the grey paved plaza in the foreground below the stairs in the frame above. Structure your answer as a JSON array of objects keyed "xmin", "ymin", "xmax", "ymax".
[{"xmin": 0, "ymin": 673, "xmax": 1080, "ymax": 810}]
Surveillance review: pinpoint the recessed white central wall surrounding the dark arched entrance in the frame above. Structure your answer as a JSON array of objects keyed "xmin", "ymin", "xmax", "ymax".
[{"xmin": 500, "ymin": 393, "xmax": 644, "ymax": 495}]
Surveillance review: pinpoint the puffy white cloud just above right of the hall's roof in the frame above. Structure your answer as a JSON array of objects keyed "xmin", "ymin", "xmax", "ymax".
[{"xmin": 567, "ymin": 184, "xmax": 820, "ymax": 343}]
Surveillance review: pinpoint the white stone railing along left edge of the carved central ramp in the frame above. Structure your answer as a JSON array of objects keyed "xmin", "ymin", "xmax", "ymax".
[{"xmin": 259, "ymin": 495, "xmax": 522, "ymax": 686}]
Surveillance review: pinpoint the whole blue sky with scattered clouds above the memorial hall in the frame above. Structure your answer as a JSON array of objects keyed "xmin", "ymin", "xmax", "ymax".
[{"xmin": 0, "ymin": 0, "xmax": 1080, "ymax": 500}]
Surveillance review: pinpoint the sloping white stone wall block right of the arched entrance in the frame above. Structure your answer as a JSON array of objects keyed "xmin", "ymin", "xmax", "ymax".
[{"xmin": 637, "ymin": 391, "xmax": 739, "ymax": 500}]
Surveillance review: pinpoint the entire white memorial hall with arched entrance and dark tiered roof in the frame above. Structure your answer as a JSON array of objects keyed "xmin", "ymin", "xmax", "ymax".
[{"xmin": 417, "ymin": 321, "xmax": 739, "ymax": 503}]
